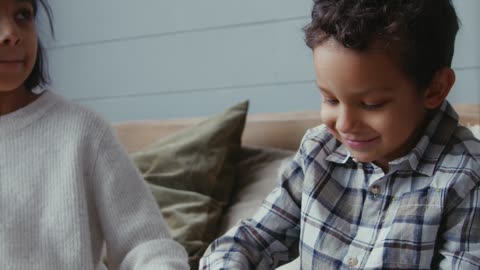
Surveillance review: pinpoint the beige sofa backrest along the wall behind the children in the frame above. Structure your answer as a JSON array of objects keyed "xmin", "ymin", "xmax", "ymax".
[{"xmin": 113, "ymin": 104, "xmax": 480, "ymax": 152}]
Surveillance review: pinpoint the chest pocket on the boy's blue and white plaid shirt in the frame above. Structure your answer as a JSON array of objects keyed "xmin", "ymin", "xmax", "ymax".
[{"xmin": 374, "ymin": 189, "xmax": 443, "ymax": 266}]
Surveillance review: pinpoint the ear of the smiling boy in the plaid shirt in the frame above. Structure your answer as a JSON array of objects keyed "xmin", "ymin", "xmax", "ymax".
[{"xmin": 424, "ymin": 67, "xmax": 455, "ymax": 109}]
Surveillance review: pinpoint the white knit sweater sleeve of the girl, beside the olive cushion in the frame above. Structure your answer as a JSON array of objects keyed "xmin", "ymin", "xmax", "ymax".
[{"xmin": 91, "ymin": 127, "xmax": 189, "ymax": 270}]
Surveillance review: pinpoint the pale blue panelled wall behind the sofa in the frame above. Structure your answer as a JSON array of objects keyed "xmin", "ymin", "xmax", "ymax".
[{"xmin": 42, "ymin": 0, "xmax": 480, "ymax": 121}]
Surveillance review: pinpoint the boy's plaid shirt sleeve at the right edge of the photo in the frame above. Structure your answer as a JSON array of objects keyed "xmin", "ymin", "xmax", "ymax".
[{"xmin": 439, "ymin": 184, "xmax": 480, "ymax": 270}]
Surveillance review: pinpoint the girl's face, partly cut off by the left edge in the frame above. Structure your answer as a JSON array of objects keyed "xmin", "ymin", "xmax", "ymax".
[{"xmin": 0, "ymin": 0, "xmax": 38, "ymax": 94}]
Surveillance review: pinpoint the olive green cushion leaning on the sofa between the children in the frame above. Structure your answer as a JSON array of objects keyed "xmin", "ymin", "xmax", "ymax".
[{"xmin": 131, "ymin": 101, "xmax": 248, "ymax": 269}]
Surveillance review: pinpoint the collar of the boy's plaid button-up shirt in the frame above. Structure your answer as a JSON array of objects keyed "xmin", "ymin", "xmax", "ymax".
[{"xmin": 326, "ymin": 101, "xmax": 458, "ymax": 176}]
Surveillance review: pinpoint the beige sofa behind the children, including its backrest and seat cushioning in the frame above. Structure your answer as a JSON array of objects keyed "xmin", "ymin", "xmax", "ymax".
[{"xmin": 114, "ymin": 104, "xmax": 480, "ymax": 269}]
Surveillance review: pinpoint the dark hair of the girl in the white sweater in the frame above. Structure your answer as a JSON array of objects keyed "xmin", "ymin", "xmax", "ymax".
[{"xmin": 25, "ymin": 0, "xmax": 54, "ymax": 91}]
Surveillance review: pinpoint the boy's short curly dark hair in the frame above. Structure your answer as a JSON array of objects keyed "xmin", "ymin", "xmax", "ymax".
[{"xmin": 303, "ymin": 0, "xmax": 459, "ymax": 89}]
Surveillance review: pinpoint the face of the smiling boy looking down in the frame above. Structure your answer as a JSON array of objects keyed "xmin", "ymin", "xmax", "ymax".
[{"xmin": 313, "ymin": 41, "xmax": 426, "ymax": 170}]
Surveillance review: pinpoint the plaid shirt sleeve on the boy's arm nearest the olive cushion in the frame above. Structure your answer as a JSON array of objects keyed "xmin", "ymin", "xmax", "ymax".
[{"xmin": 200, "ymin": 147, "xmax": 304, "ymax": 270}]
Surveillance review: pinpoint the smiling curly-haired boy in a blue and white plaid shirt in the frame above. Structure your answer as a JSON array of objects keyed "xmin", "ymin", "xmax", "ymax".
[{"xmin": 201, "ymin": 0, "xmax": 480, "ymax": 269}]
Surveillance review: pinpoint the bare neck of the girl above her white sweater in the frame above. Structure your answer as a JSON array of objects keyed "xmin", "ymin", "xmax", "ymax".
[{"xmin": 0, "ymin": 86, "xmax": 39, "ymax": 115}]
